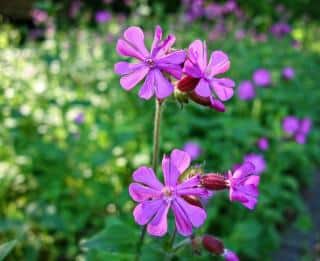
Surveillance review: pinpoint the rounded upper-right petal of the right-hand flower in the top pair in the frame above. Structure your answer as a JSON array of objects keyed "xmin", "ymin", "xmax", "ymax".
[{"xmin": 207, "ymin": 51, "xmax": 230, "ymax": 77}]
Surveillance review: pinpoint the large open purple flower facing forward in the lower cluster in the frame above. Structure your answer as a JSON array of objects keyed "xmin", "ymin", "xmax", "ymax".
[{"xmin": 129, "ymin": 150, "xmax": 207, "ymax": 236}]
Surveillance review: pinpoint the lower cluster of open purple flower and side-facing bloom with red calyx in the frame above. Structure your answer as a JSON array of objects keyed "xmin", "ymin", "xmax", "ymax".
[{"xmin": 129, "ymin": 149, "xmax": 260, "ymax": 236}]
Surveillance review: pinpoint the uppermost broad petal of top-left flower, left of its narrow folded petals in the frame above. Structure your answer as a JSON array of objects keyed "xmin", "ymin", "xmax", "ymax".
[{"xmin": 123, "ymin": 26, "xmax": 149, "ymax": 57}]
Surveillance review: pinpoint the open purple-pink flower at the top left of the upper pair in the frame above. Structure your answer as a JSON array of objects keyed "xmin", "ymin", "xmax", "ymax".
[{"xmin": 115, "ymin": 26, "xmax": 186, "ymax": 100}]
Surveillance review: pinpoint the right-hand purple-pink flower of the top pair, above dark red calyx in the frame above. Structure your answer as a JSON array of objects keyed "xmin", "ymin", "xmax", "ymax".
[{"xmin": 183, "ymin": 40, "xmax": 235, "ymax": 111}]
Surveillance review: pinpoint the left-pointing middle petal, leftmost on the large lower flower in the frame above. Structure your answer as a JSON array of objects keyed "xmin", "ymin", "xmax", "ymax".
[{"xmin": 129, "ymin": 183, "xmax": 161, "ymax": 202}]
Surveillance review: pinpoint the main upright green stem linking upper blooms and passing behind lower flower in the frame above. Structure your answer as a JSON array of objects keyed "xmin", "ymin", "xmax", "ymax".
[{"xmin": 135, "ymin": 99, "xmax": 162, "ymax": 261}]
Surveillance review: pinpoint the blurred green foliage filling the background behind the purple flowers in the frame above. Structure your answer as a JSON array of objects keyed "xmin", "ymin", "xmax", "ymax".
[{"xmin": 0, "ymin": 3, "xmax": 320, "ymax": 260}]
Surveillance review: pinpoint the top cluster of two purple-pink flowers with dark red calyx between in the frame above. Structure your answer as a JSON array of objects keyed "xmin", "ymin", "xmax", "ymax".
[{"xmin": 115, "ymin": 26, "xmax": 235, "ymax": 111}]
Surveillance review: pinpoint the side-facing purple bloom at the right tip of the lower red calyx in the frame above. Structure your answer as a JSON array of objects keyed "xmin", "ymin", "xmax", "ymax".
[{"xmin": 227, "ymin": 162, "xmax": 260, "ymax": 208}]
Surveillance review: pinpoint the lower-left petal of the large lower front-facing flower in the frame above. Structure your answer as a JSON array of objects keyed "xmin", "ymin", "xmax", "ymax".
[{"xmin": 133, "ymin": 199, "xmax": 163, "ymax": 226}]
